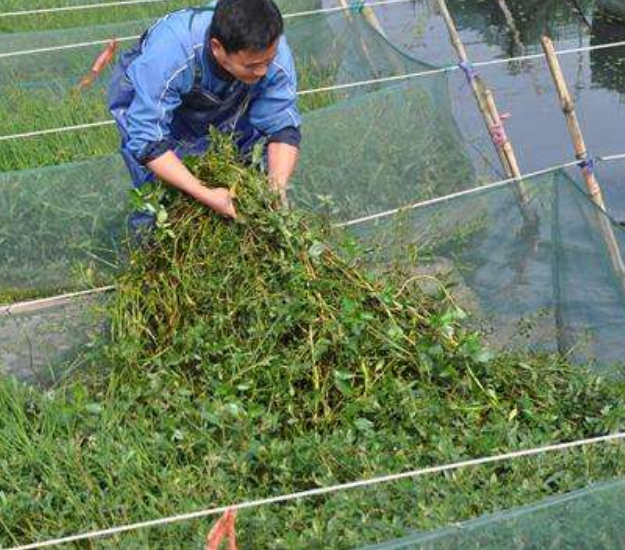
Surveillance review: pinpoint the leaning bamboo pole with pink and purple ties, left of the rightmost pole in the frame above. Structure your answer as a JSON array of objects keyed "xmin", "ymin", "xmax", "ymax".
[{"xmin": 437, "ymin": 0, "xmax": 538, "ymax": 225}]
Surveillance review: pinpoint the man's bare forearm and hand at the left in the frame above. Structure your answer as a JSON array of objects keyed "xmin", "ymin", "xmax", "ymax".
[{"xmin": 146, "ymin": 151, "xmax": 236, "ymax": 218}]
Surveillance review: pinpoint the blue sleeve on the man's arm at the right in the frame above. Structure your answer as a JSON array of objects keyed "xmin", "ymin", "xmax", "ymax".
[{"xmin": 250, "ymin": 38, "xmax": 301, "ymax": 145}]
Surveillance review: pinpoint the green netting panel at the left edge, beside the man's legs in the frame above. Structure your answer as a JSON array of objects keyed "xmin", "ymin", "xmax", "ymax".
[{"xmin": 0, "ymin": 156, "xmax": 129, "ymax": 300}]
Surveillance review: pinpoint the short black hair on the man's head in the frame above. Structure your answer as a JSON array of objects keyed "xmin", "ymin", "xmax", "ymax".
[{"xmin": 209, "ymin": 0, "xmax": 284, "ymax": 53}]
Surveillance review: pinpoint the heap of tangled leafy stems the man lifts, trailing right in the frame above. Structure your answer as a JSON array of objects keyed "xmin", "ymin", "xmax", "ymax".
[{"xmin": 109, "ymin": 134, "xmax": 624, "ymax": 439}]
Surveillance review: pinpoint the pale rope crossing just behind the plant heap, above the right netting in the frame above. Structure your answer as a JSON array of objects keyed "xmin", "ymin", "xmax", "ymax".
[{"xmin": 0, "ymin": 153, "xmax": 625, "ymax": 314}]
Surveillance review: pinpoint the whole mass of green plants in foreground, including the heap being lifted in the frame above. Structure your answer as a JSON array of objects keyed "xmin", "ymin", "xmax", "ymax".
[{"xmin": 0, "ymin": 142, "xmax": 625, "ymax": 548}]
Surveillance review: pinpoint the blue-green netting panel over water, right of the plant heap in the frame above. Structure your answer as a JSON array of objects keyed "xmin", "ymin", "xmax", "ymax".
[{"xmin": 354, "ymin": 167, "xmax": 625, "ymax": 365}]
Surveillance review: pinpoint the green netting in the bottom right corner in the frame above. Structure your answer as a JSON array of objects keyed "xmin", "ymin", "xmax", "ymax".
[{"xmin": 360, "ymin": 479, "xmax": 625, "ymax": 550}]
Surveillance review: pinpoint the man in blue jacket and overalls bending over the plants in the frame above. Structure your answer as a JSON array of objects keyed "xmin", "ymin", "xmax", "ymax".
[{"xmin": 109, "ymin": 0, "xmax": 301, "ymax": 222}]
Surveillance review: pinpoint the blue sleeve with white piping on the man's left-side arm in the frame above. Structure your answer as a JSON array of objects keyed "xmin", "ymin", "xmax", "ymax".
[{"xmin": 126, "ymin": 26, "xmax": 195, "ymax": 163}]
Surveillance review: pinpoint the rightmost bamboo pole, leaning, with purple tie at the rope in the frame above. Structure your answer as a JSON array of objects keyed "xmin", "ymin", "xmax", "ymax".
[{"xmin": 541, "ymin": 36, "xmax": 625, "ymax": 284}]
